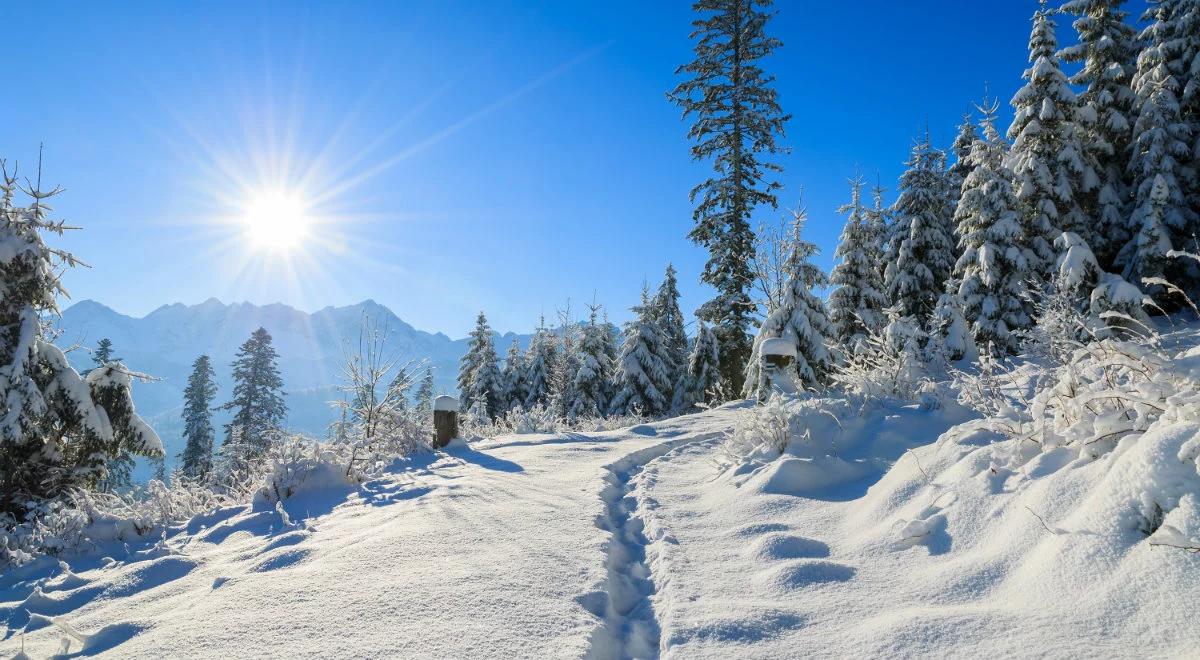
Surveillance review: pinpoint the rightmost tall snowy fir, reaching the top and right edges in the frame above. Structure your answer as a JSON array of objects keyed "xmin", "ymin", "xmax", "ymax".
[{"xmin": 1117, "ymin": 2, "xmax": 1200, "ymax": 297}]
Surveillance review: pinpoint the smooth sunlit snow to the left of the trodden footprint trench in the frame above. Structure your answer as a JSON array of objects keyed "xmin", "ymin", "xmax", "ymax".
[{"xmin": 0, "ymin": 415, "xmax": 730, "ymax": 658}]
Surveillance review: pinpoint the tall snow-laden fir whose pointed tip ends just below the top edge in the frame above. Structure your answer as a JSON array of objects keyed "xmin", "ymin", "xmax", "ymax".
[{"xmin": 1008, "ymin": 8, "xmax": 1099, "ymax": 268}]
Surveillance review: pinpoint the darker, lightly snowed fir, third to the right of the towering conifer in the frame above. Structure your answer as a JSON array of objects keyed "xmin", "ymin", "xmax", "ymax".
[{"xmin": 884, "ymin": 131, "xmax": 956, "ymax": 323}]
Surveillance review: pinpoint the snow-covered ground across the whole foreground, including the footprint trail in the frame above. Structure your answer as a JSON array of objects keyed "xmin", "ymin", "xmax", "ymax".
[{"xmin": 0, "ymin": 379, "xmax": 1200, "ymax": 658}]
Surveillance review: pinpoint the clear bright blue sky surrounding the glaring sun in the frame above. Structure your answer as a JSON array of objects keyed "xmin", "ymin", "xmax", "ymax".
[{"xmin": 0, "ymin": 0, "xmax": 1156, "ymax": 336}]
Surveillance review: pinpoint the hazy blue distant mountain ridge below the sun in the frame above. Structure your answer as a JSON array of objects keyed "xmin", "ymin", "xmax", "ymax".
[{"xmin": 56, "ymin": 298, "xmax": 532, "ymax": 472}]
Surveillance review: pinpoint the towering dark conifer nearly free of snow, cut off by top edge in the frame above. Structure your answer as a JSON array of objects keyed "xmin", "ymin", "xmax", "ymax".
[{"xmin": 668, "ymin": 0, "xmax": 788, "ymax": 396}]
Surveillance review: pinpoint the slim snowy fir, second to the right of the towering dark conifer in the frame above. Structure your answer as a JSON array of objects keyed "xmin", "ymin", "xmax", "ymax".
[{"xmin": 829, "ymin": 176, "xmax": 886, "ymax": 349}]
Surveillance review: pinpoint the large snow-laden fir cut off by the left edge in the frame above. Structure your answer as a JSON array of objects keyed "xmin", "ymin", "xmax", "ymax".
[{"xmin": 0, "ymin": 162, "xmax": 162, "ymax": 518}]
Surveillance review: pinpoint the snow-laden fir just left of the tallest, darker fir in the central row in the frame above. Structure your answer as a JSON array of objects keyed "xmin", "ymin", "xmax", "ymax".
[{"xmin": 610, "ymin": 287, "xmax": 671, "ymax": 418}]
